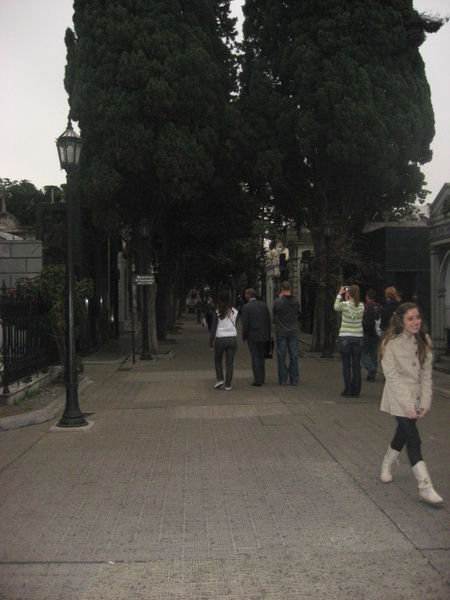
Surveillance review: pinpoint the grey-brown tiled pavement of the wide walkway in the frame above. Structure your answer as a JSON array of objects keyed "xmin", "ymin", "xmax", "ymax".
[{"xmin": 0, "ymin": 316, "xmax": 450, "ymax": 600}]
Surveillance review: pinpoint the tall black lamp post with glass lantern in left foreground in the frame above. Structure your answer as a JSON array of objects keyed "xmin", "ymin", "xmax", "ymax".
[{"xmin": 56, "ymin": 118, "xmax": 88, "ymax": 427}]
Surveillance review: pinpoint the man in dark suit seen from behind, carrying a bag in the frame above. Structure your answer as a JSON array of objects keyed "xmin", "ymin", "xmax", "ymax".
[{"xmin": 242, "ymin": 288, "xmax": 271, "ymax": 387}]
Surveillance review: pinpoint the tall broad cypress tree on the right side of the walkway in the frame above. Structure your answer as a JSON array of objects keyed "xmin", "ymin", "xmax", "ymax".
[{"xmin": 241, "ymin": 0, "xmax": 442, "ymax": 350}]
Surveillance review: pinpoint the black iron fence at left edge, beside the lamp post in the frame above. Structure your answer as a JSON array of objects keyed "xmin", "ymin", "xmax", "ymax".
[{"xmin": 0, "ymin": 288, "xmax": 58, "ymax": 394}]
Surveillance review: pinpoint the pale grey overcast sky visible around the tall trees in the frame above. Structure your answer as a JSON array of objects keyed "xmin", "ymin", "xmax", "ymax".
[{"xmin": 0, "ymin": 0, "xmax": 450, "ymax": 201}]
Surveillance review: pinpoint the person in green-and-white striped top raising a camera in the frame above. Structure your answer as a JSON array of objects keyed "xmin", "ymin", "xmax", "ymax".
[{"xmin": 334, "ymin": 284, "xmax": 364, "ymax": 398}]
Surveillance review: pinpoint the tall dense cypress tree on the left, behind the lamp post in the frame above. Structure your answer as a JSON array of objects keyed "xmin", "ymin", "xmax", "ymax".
[{"xmin": 65, "ymin": 0, "xmax": 239, "ymax": 342}]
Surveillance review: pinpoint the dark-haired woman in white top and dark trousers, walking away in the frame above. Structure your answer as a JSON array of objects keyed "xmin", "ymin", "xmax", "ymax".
[{"xmin": 209, "ymin": 292, "xmax": 238, "ymax": 392}]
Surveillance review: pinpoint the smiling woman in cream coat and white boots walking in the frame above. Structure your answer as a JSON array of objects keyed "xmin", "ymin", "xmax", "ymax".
[{"xmin": 380, "ymin": 302, "xmax": 443, "ymax": 506}]
